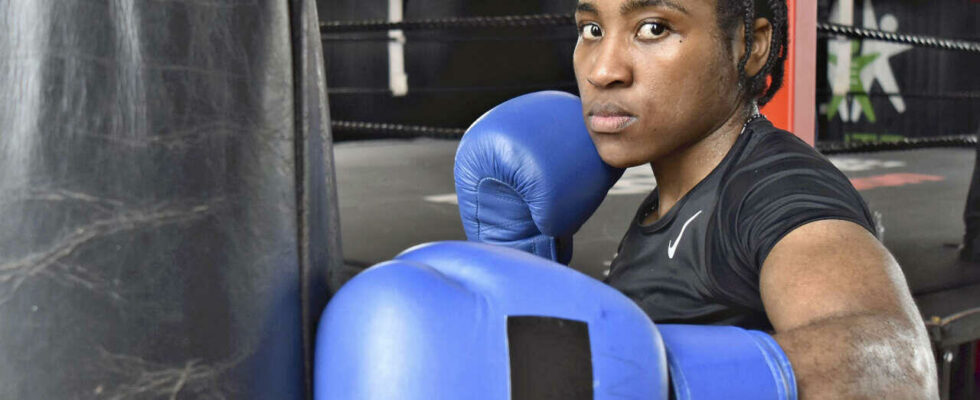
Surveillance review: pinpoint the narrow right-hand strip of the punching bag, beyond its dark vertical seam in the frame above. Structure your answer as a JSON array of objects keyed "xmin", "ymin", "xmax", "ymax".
[{"xmin": 291, "ymin": 0, "xmax": 346, "ymax": 398}]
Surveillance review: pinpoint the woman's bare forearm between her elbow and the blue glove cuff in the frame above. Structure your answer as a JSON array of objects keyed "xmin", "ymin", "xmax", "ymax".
[{"xmin": 773, "ymin": 314, "xmax": 938, "ymax": 400}]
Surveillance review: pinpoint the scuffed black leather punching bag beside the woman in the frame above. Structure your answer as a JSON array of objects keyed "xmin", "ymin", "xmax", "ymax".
[{"xmin": 0, "ymin": 0, "xmax": 340, "ymax": 400}]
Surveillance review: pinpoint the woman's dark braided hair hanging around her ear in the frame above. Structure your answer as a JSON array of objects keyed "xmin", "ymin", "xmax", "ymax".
[{"xmin": 717, "ymin": 0, "xmax": 789, "ymax": 106}]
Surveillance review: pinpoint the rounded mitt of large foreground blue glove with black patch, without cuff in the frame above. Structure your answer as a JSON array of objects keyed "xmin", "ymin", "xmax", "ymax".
[{"xmin": 314, "ymin": 242, "xmax": 668, "ymax": 400}]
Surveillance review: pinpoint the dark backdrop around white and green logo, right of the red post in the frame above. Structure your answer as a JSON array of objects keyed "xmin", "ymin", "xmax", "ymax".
[{"xmin": 817, "ymin": 0, "xmax": 980, "ymax": 141}]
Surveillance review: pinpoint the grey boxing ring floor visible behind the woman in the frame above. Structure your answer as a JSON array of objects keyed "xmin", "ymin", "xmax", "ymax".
[{"xmin": 335, "ymin": 139, "xmax": 980, "ymax": 295}]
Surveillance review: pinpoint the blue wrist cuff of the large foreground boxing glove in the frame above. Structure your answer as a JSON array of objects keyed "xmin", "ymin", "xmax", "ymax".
[{"xmin": 657, "ymin": 325, "xmax": 797, "ymax": 400}]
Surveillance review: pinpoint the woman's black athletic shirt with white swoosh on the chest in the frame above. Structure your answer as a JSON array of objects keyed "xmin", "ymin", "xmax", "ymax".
[{"xmin": 606, "ymin": 118, "xmax": 875, "ymax": 330}]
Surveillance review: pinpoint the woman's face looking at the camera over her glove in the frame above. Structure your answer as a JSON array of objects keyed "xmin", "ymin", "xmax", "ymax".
[{"xmin": 574, "ymin": 0, "xmax": 740, "ymax": 167}]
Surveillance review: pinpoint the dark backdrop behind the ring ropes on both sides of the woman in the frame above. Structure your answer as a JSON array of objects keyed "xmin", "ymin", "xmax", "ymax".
[{"xmin": 319, "ymin": 0, "xmax": 980, "ymax": 141}]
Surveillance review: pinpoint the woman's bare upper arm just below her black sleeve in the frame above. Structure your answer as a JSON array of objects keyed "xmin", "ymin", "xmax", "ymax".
[{"xmin": 759, "ymin": 219, "xmax": 919, "ymax": 333}]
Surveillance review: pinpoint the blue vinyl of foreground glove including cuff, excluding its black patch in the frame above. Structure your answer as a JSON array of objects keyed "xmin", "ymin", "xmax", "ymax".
[{"xmin": 314, "ymin": 242, "xmax": 797, "ymax": 400}]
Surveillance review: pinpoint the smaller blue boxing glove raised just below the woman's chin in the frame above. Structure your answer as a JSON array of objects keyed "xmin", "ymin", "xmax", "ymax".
[{"xmin": 454, "ymin": 91, "xmax": 623, "ymax": 264}]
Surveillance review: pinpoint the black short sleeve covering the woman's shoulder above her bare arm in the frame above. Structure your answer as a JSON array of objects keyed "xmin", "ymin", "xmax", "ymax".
[{"xmin": 715, "ymin": 121, "xmax": 875, "ymax": 267}]
